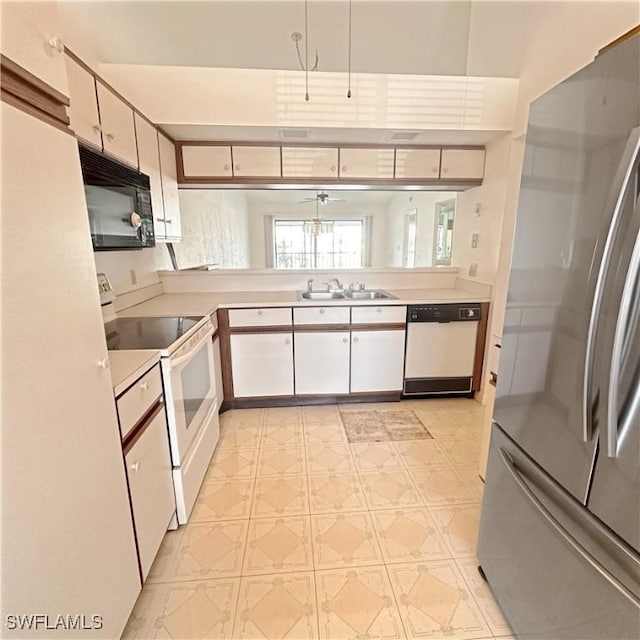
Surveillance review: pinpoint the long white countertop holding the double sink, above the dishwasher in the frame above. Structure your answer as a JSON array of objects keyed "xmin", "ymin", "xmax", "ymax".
[{"xmin": 118, "ymin": 289, "xmax": 489, "ymax": 317}]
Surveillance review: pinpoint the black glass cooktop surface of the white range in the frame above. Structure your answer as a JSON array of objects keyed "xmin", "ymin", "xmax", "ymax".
[{"xmin": 104, "ymin": 316, "xmax": 202, "ymax": 351}]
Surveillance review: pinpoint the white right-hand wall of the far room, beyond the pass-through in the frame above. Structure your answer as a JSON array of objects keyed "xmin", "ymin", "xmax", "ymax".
[{"xmin": 386, "ymin": 191, "xmax": 458, "ymax": 267}]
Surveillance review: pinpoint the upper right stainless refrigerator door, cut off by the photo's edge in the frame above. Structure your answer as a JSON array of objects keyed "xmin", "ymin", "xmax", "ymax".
[{"xmin": 588, "ymin": 196, "xmax": 640, "ymax": 550}]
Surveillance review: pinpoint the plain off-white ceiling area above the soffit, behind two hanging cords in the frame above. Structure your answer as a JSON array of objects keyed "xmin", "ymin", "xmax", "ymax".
[{"xmin": 59, "ymin": 0, "xmax": 557, "ymax": 77}]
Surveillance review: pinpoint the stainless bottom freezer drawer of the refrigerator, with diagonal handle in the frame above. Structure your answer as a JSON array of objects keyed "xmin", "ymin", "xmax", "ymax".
[{"xmin": 478, "ymin": 424, "xmax": 640, "ymax": 640}]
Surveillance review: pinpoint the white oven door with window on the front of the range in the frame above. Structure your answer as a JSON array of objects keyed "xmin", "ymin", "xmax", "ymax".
[{"xmin": 162, "ymin": 327, "xmax": 216, "ymax": 467}]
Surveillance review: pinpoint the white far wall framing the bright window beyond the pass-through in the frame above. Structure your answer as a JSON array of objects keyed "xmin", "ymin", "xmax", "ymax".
[{"xmin": 249, "ymin": 201, "xmax": 387, "ymax": 269}]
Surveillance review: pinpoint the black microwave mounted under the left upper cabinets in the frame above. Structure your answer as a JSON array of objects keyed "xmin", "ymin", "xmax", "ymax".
[{"xmin": 79, "ymin": 145, "xmax": 156, "ymax": 251}]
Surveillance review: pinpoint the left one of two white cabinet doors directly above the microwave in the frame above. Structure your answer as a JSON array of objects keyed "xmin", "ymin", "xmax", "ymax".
[{"xmin": 65, "ymin": 56, "xmax": 102, "ymax": 151}]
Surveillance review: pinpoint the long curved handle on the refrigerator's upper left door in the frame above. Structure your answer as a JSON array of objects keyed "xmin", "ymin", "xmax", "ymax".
[{"xmin": 582, "ymin": 127, "xmax": 640, "ymax": 442}]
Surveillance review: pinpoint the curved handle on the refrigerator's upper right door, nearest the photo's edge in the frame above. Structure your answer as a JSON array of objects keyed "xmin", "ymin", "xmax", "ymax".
[{"xmin": 606, "ymin": 228, "xmax": 640, "ymax": 458}]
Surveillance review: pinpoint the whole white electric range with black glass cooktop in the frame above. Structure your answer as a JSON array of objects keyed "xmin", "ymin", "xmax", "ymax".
[{"xmin": 98, "ymin": 274, "xmax": 220, "ymax": 524}]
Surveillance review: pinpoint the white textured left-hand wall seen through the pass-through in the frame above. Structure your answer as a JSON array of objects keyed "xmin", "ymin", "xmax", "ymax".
[{"xmin": 174, "ymin": 189, "xmax": 250, "ymax": 269}]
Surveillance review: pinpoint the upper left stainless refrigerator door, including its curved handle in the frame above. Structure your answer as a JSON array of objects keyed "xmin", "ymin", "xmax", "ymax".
[{"xmin": 494, "ymin": 37, "xmax": 640, "ymax": 502}]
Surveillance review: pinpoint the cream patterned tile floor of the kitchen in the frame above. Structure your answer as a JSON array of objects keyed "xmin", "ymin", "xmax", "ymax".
[{"xmin": 124, "ymin": 399, "xmax": 511, "ymax": 640}]
